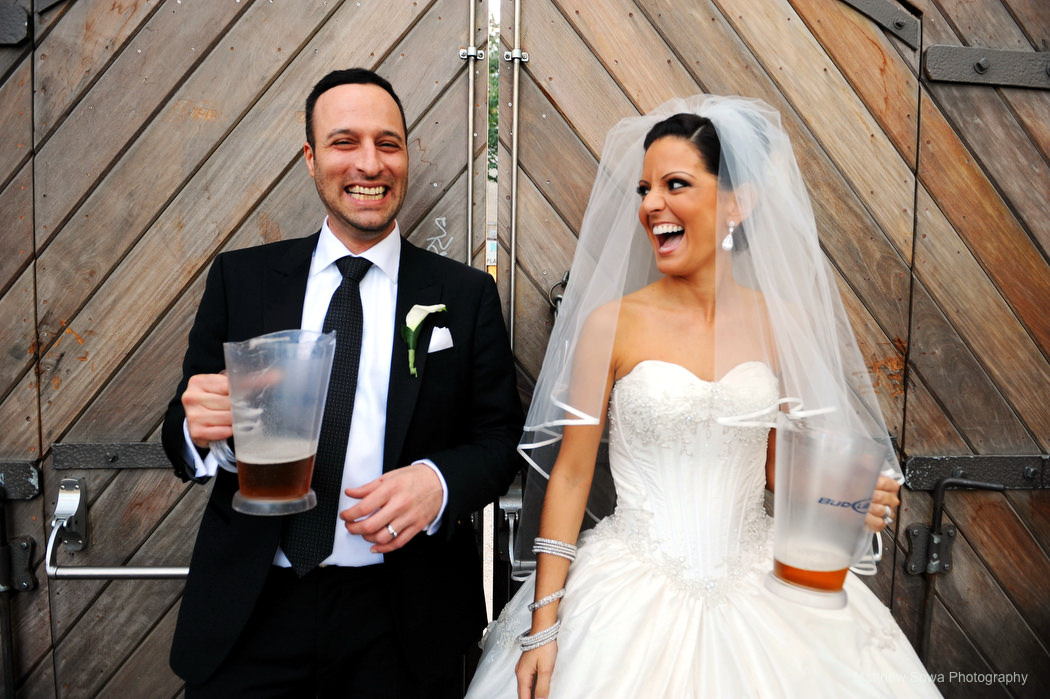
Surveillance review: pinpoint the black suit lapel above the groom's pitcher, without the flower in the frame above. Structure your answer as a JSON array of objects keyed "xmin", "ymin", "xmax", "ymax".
[{"xmin": 263, "ymin": 233, "xmax": 319, "ymax": 334}]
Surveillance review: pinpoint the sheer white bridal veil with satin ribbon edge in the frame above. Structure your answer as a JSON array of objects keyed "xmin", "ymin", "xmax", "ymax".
[{"xmin": 518, "ymin": 94, "xmax": 899, "ymax": 552}]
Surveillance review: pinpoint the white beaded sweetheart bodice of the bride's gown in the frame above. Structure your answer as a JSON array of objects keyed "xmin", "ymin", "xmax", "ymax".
[{"xmin": 594, "ymin": 360, "xmax": 777, "ymax": 590}]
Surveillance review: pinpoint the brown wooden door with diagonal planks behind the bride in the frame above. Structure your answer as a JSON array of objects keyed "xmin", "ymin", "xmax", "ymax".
[{"xmin": 499, "ymin": 0, "xmax": 1050, "ymax": 696}]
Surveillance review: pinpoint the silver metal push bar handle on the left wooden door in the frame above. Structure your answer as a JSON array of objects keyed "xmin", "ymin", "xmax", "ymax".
[{"xmin": 44, "ymin": 479, "xmax": 189, "ymax": 580}]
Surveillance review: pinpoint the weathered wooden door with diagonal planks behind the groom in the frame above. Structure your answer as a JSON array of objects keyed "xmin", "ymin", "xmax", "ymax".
[{"xmin": 0, "ymin": 0, "xmax": 487, "ymax": 697}]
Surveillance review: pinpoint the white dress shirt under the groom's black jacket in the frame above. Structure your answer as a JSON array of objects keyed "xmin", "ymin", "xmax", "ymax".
[{"xmin": 184, "ymin": 218, "xmax": 448, "ymax": 568}]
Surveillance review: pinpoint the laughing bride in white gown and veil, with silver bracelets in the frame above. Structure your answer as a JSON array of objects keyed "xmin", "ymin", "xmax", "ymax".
[{"xmin": 467, "ymin": 96, "xmax": 937, "ymax": 699}]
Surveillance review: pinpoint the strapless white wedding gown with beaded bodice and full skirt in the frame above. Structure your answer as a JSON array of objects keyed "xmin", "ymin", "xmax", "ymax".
[{"xmin": 467, "ymin": 360, "xmax": 939, "ymax": 699}]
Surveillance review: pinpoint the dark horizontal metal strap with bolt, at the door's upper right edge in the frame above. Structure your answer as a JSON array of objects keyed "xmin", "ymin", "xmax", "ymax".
[{"xmin": 923, "ymin": 45, "xmax": 1050, "ymax": 89}]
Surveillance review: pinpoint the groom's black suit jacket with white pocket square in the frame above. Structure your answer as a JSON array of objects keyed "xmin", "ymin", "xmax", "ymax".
[{"xmin": 163, "ymin": 234, "xmax": 523, "ymax": 683}]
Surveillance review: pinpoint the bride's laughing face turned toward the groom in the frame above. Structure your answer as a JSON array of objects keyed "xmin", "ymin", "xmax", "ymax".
[{"xmin": 638, "ymin": 136, "xmax": 725, "ymax": 276}]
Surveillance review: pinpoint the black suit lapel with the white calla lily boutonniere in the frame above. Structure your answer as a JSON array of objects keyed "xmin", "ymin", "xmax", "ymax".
[{"xmin": 383, "ymin": 238, "xmax": 442, "ymax": 471}]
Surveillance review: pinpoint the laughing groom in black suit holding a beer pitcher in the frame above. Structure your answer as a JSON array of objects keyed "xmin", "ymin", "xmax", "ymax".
[{"xmin": 163, "ymin": 68, "xmax": 523, "ymax": 699}]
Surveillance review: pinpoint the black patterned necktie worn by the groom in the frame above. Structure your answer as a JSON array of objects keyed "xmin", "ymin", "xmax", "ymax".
[{"xmin": 281, "ymin": 255, "xmax": 372, "ymax": 577}]
